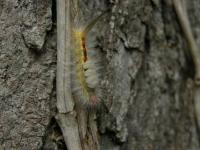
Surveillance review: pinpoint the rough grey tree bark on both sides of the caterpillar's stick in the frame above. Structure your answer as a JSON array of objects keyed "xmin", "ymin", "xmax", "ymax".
[{"xmin": 0, "ymin": 0, "xmax": 200, "ymax": 150}]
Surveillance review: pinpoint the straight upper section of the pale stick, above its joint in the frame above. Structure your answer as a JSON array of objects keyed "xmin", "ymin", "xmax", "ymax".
[{"xmin": 56, "ymin": 0, "xmax": 74, "ymax": 113}]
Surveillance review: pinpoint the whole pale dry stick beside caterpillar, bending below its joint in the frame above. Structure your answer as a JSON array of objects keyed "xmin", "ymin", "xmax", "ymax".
[{"xmin": 56, "ymin": 0, "xmax": 82, "ymax": 150}]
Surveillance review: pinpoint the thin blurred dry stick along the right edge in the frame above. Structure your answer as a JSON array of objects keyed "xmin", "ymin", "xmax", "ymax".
[{"xmin": 173, "ymin": 0, "xmax": 200, "ymax": 128}]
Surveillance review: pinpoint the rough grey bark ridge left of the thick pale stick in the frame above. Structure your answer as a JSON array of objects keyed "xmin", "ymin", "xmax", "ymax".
[{"xmin": 0, "ymin": 0, "xmax": 56, "ymax": 150}]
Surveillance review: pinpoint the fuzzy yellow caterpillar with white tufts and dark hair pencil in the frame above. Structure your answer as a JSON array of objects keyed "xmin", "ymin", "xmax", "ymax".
[{"xmin": 71, "ymin": 12, "xmax": 106, "ymax": 108}]
